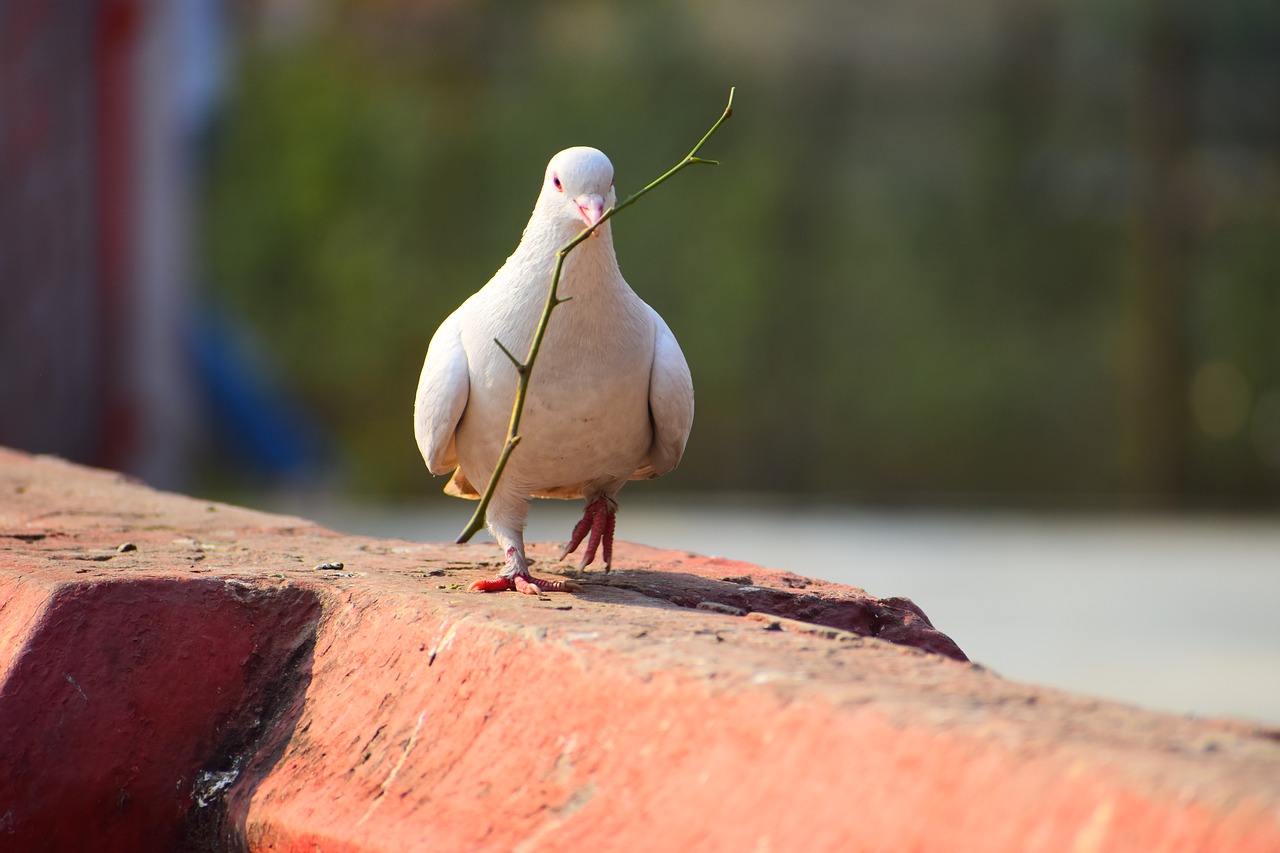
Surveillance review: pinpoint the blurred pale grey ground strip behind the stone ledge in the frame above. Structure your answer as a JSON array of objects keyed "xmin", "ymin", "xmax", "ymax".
[{"xmin": 264, "ymin": 492, "xmax": 1280, "ymax": 725}]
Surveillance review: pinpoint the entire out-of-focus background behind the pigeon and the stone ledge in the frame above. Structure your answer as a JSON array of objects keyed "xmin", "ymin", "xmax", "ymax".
[{"xmin": 0, "ymin": 0, "xmax": 1280, "ymax": 722}]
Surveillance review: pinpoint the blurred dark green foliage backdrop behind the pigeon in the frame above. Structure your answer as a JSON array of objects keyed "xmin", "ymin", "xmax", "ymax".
[{"xmin": 205, "ymin": 0, "xmax": 1280, "ymax": 505}]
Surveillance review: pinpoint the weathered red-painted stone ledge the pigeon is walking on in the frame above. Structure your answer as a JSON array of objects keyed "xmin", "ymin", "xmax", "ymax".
[{"xmin": 0, "ymin": 450, "xmax": 1280, "ymax": 852}]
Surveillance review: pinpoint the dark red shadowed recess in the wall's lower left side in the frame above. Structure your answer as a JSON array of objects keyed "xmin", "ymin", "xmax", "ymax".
[{"xmin": 0, "ymin": 580, "xmax": 320, "ymax": 852}]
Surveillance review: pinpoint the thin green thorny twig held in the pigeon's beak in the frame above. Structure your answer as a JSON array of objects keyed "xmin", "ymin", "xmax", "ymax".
[{"xmin": 458, "ymin": 87, "xmax": 733, "ymax": 544}]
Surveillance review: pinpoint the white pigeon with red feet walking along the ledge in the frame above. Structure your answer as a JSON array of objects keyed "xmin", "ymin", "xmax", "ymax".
[{"xmin": 413, "ymin": 147, "xmax": 694, "ymax": 594}]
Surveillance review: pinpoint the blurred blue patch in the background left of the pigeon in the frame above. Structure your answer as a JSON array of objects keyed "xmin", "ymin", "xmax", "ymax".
[{"xmin": 191, "ymin": 305, "xmax": 332, "ymax": 480}]
